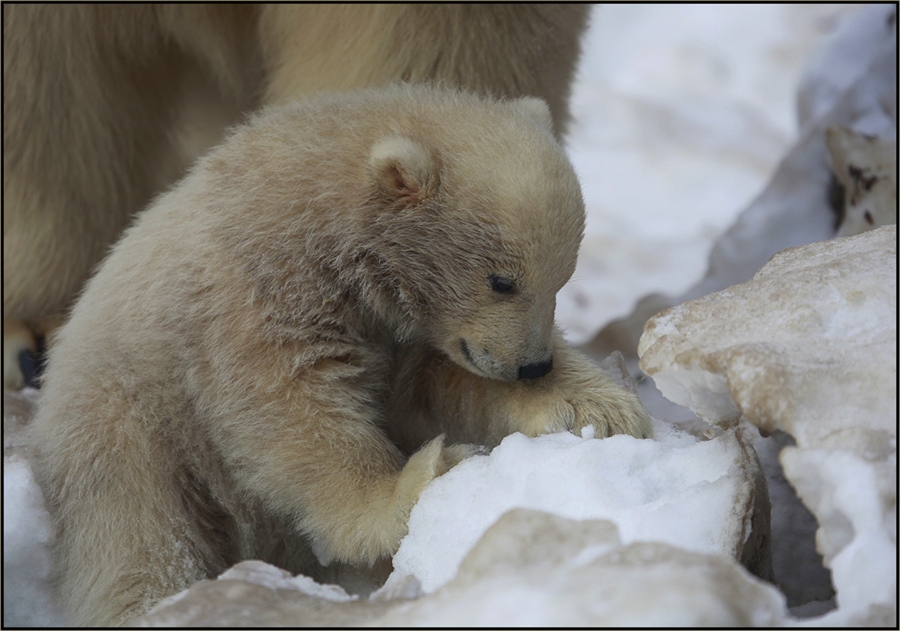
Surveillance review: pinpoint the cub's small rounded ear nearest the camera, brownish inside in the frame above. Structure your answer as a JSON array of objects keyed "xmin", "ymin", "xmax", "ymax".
[{"xmin": 369, "ymin": 136, "xmax": 439, "ymax": 204}]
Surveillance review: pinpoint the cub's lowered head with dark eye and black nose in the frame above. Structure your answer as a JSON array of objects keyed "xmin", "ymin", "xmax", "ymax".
[{"xmin": 367, "ymin": 95, "xmax": 584, "ymax": 381}]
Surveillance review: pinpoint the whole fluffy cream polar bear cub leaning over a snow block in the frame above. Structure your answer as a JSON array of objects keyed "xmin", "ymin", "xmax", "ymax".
[{"xmin": 33, "ymin": 86, "xmax": 651, "ymax": 624}]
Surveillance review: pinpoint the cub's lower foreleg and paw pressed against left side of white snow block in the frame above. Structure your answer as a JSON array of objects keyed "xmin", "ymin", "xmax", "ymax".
[{"xmin": 197, "ymin": 370, "xmax": 475, "ymax": 565}]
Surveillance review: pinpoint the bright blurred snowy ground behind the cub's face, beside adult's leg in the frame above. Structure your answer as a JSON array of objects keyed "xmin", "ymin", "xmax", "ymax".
[{"xmin": 557, "ymin": 3, "xmax": 853, "ymax": 343}]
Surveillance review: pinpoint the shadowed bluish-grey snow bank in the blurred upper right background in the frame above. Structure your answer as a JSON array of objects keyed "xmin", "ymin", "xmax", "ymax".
[{"xmin": 673, "ymin": 5, "xmax": 897, "ymax": 304}]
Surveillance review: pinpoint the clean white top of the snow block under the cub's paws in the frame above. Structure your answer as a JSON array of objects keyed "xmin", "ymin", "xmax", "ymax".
[{"xmin": 387, "ymin": 422, "xmax": 753, "ymax": 592}]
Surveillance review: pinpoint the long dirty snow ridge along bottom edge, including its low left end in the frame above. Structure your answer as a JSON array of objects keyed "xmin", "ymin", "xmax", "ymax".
[{"xmin": 135, "ymin": 509, "xmax": 787, "ymax": 628}]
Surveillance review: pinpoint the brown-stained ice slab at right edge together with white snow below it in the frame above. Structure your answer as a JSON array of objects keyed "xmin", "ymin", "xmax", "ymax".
[{"xmin": 638, "ymin": 224, "xmax": 897, "ymax": 625}]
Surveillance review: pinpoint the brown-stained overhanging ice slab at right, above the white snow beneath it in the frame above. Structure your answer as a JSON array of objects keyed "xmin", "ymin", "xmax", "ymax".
[{"xmin": 638, "ymin": 224, "xmax": 897, "ymax": 442}]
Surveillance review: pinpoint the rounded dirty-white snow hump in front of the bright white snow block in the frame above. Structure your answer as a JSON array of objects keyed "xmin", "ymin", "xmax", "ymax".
[{"xmin": 370, "ymin": 509, "xmax": 785, "ymax": 627}]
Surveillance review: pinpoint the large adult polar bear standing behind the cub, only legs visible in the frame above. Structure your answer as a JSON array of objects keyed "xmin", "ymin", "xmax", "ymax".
[{"xmin": 3, "ymin": 4, "xmax": 589, "ymax": 387}]
